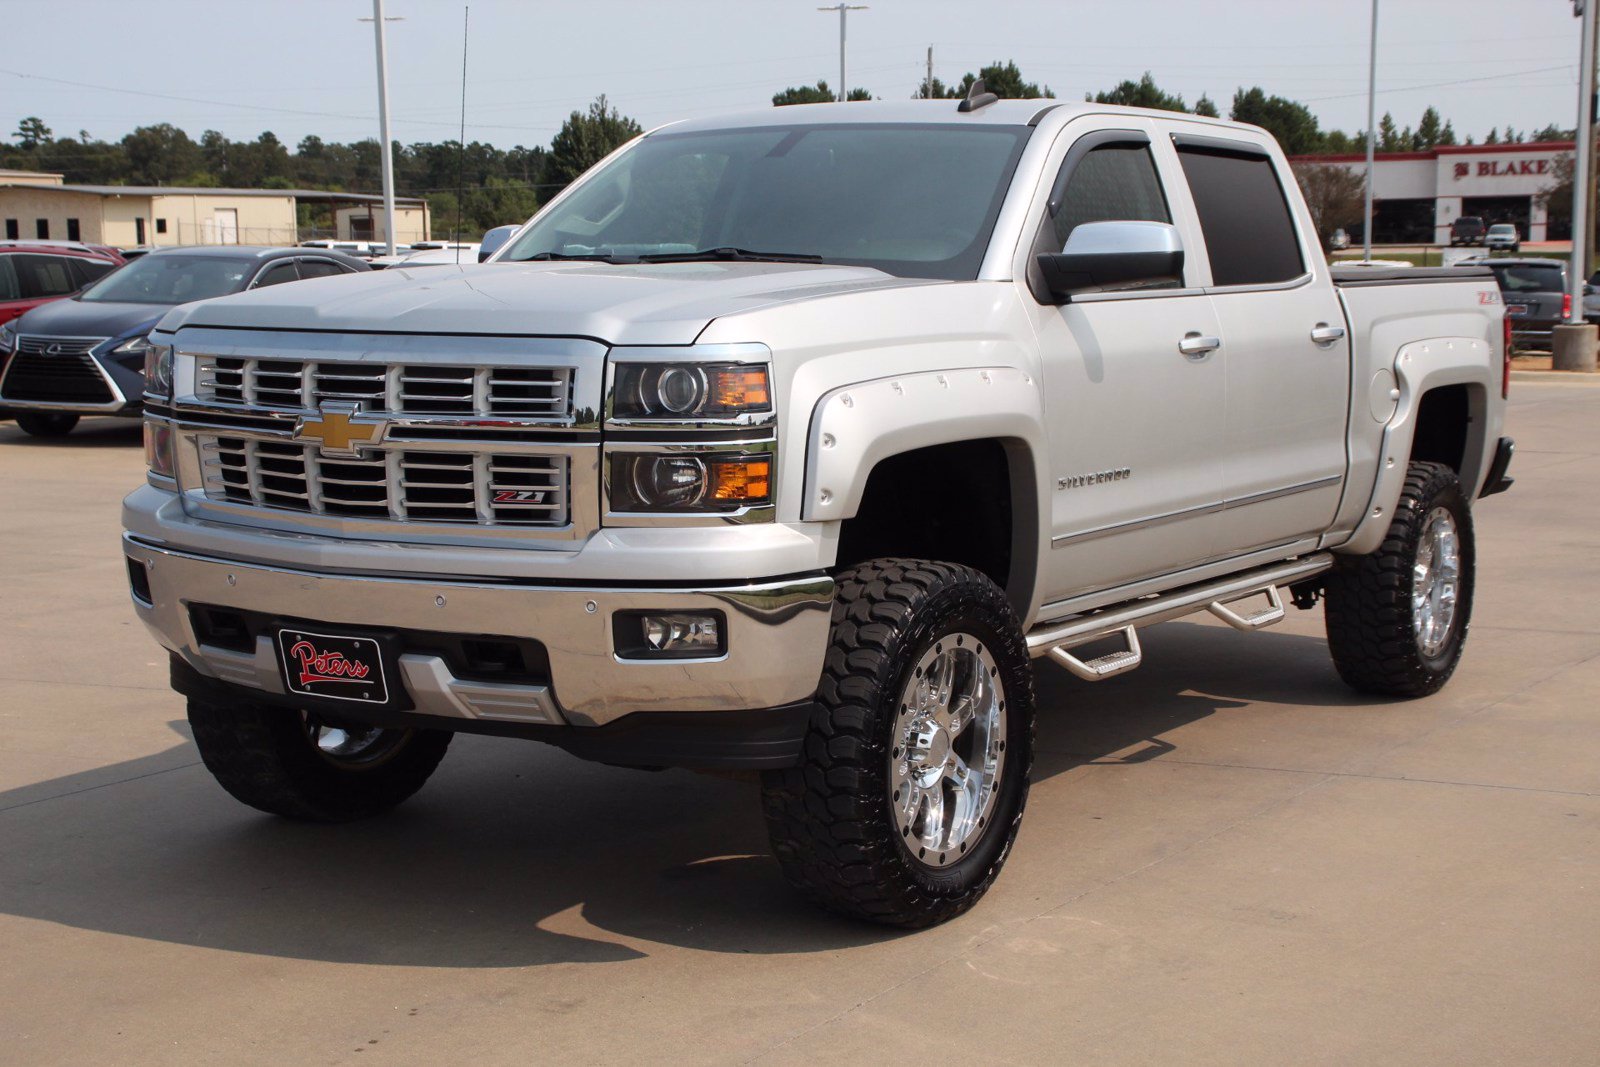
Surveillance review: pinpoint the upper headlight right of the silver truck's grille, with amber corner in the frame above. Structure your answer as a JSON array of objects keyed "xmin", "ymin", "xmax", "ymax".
[{"xmin": 611, "ymin": 363, "xmax": 773, "ymax": 422}]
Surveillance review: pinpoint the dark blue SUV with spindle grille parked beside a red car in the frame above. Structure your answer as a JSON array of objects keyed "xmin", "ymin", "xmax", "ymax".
[{"xmin": 0, "ymin": 245, "xmax": 366, "ymax": 437}]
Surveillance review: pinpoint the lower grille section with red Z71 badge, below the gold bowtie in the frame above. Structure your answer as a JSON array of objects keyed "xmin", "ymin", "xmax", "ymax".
[{"xmin": 198, "ymin": 435, "xmax": 568, "ymax": 526}]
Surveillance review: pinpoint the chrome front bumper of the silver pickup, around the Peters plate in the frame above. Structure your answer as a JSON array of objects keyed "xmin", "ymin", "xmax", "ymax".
[{"xmin": 123, "ymin": 534, "xmax": 834, "ymax": 726}]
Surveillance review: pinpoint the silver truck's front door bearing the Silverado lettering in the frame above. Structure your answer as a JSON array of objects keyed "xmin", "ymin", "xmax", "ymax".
[{"xmin": 1026, "ymin": 117, "xmax": 1227, "ymax": 605}]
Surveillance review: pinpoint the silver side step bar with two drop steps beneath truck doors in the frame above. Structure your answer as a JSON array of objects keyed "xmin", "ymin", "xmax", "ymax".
[{"xmin": 1027, "ymin": 552, "xmax": 1333, "ymax": 681}]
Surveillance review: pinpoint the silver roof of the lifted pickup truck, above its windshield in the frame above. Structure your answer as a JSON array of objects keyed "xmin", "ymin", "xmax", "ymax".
[{"xmin": 651, "ymin": 98, "xmax": 1254, "ymax": 133}]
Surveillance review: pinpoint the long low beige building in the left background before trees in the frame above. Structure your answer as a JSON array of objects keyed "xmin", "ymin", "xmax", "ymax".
[{"xmin": 0, "ymin": 181, "xmax": 429, "ymax": 248}]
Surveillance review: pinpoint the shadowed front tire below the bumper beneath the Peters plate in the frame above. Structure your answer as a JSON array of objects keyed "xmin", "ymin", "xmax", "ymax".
[{"xmin": 189, "ymin": 699, "xmax": 453, "ymax": 822}]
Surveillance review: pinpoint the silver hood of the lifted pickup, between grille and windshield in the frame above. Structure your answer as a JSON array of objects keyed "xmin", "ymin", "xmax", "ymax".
[{"xmin": 162, "ymin": 262, "xmax": 947, "ymax": 346}]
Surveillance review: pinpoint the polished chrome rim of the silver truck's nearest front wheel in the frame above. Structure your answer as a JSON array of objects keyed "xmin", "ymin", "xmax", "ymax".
[{"xmin": 890, "ymin": 633, "xmax": 1006, "ymax": 867}]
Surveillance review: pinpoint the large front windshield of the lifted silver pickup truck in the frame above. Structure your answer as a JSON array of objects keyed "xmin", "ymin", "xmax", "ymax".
[{"xmin": 502, "ymin": 123, "xmax": 1030, "ymax": 278}]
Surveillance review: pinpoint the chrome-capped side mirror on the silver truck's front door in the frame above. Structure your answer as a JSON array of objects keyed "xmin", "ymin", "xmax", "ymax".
[{"xmin": 1037, "ymin": 222, "xmax": 1184, "ymax": 304}]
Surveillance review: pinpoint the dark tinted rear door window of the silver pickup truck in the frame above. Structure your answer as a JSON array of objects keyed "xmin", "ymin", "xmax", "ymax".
[{"xmin": 1178, "ymin": 146, "xmax": 1306, "ymax": 286}]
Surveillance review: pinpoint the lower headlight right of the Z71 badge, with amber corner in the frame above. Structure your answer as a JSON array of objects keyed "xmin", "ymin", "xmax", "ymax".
[{"xmin": 611, "ymin": 453, "xmax": 773, "ymax": 514}]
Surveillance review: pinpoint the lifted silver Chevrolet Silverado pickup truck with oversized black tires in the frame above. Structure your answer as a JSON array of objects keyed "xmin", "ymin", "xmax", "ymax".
[{"xmin": 123, "ymin": 93, "xmax": 1510, "ymax": 926}]
